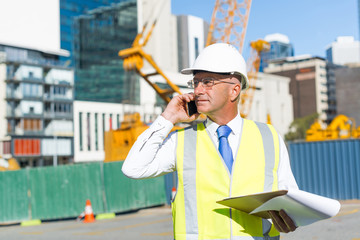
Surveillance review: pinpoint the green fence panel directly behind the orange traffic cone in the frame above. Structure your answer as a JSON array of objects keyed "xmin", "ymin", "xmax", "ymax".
[{"xmin": 29, "ymin": 163, "xmax": 104, "ymax": 219}]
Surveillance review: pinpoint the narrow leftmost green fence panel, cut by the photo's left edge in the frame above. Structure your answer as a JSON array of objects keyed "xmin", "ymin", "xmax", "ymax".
[{"xmin": 0, "ymin": 170, "xmax": 29, "ymax": 222}]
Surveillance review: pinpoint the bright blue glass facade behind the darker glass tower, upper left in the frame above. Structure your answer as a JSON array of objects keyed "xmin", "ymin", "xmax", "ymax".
[{"xmin": 60, "ymin": 0, "xmax": 124, "ymax": 66}]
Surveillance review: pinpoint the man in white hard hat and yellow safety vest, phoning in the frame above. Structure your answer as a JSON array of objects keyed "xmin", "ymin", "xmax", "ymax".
[{"xmin": 122, "ymin": 43, "xmax": 297, "ymax": 240}]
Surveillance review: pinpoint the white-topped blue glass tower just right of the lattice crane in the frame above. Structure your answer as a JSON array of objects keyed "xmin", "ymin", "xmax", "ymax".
[{"xmin": 259, "ymin": 33, "xmax": 294, "ymax": 72}]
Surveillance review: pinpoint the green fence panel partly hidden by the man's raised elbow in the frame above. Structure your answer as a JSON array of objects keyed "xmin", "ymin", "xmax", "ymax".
[{"xmin": 104, "ymin": 162, "xmax": 166, "ymax": 212}]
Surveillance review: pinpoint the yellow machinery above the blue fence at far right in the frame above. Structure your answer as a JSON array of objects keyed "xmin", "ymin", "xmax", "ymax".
[{"xmin": 306, "ymin": 115, "xmax": 360, "ymax": 141}]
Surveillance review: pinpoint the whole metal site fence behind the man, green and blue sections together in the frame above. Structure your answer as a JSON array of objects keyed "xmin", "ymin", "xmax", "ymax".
[{"xmin": 0, "ymin": 139, "xmax": 360, "ymax": 222}]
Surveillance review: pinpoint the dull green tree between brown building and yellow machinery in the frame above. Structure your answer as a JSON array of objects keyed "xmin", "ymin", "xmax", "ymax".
[{"xmin": 285, "ymin": 113, "xmax": 319, "ymax": 141}]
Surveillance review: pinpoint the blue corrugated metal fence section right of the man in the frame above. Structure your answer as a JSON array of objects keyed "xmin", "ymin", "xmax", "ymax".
[{"xmin": 288, "ymin": 139, "xmax": 360, "ymax": 200}]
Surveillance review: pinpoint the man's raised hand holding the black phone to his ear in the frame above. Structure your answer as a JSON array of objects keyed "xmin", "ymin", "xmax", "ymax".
[{"xmin": 161, "ymin": 93, "xmax": 200, "ymax": 124}]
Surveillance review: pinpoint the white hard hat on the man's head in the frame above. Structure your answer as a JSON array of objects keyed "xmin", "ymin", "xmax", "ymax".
[{"xmin": 181, "ymin": 43, "xmax": 249, "ymax": 90}]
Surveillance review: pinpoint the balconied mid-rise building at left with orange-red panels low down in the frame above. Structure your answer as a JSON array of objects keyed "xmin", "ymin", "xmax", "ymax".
[{"xmin": 0, "ymin": 45, "xmax": 74, "ymax": 167}]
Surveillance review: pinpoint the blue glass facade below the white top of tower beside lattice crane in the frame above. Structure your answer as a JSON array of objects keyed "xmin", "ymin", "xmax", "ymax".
[{"xmin": 259, "ymin": 41, "xmax": 294, "ymax": 72}]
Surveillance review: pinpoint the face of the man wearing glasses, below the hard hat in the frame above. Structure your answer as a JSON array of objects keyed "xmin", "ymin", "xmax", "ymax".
[{"xmin": 194, "ymin": 72, "xmax": 240, "ymax": 117}]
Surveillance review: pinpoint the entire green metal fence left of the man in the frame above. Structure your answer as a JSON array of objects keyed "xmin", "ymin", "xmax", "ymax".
[{"xmin": 0, "ymin": 162, "xmax": 166, "ymax": 222}]
